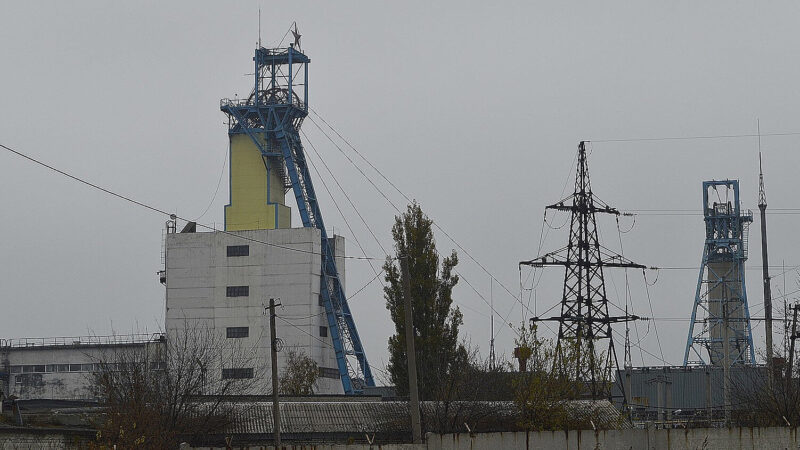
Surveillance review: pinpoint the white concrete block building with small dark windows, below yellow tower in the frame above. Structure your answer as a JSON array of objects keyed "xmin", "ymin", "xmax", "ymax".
[{"xmin": 166, "ymin": 228, "xmax": 344, "ymax": 394}]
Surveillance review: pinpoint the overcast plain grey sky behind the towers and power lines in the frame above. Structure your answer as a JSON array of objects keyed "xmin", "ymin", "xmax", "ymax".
[{"xmin": 0, "ymin": 1, "xmax": 800, "ymax": 380}]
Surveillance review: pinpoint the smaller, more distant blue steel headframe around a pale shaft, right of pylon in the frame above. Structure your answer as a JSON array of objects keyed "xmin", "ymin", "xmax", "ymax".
[{"xmin": 683, "ymin": 180, "xmax": 755, "ymax": 365}]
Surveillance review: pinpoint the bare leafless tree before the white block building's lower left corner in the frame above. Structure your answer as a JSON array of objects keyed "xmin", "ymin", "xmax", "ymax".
[{"xmin": 93, "ymin": 322, "xmax": 262, "ymax": 449}]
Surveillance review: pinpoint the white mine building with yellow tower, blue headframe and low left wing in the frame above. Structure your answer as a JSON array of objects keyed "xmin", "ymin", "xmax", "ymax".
[{"xmin": 0, "ymin": 37, "xmax": 374, "ymax": 399}]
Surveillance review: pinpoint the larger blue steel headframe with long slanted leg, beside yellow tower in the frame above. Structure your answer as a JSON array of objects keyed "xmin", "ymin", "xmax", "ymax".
[{"xmin": 220, "ymin": 46, "xmax": 375, "ymax": 394}]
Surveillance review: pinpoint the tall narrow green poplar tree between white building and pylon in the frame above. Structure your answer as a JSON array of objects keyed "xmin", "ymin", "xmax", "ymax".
[{"xmin": 383, "ymin": 202, "xmax": 468, "ymax": 400}]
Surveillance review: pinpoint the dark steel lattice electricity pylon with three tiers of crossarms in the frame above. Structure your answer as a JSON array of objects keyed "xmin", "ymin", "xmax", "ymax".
[{"xmin": 520, "ymin": 142, "xmax": 645, "ymax": 399}]
